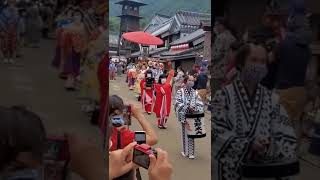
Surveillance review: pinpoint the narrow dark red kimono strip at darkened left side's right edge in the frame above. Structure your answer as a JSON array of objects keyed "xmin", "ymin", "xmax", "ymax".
[{"xmin": 98, "ymin": 53, "xmax": 109, "ymax": 132}]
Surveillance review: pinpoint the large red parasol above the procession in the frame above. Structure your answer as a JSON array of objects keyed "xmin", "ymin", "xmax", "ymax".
[{"xmin": 122, "ymin": 31, "xmax": 163, "ymax": 45}]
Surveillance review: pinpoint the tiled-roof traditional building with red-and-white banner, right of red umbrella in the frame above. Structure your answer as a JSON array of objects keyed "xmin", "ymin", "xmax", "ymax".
[{"xmin": 131, "ymin": 11, "xmax": 211, "ymax": 70}]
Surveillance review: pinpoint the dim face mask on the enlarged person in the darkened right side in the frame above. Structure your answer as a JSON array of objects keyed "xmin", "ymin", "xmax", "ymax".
[{"xmin": 241, "ymin": 64, "xmax": 268, "ymax": 84}]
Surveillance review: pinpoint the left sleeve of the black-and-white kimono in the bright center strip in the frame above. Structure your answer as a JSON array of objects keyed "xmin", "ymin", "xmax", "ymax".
[{"xmin": 174, "ymin": 89, "xmax": 188, "ymax": 123}]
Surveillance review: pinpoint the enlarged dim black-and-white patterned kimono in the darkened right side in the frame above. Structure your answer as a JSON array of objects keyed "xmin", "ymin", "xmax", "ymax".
[{"xmin": 212, "ymin": 79, "xmax": 297, "ymax": 180}]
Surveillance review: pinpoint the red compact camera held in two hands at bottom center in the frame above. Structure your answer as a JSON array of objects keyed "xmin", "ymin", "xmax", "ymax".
[{"xmin": 133, "ymin": 144, "xmax": 157, "ymax": 169}]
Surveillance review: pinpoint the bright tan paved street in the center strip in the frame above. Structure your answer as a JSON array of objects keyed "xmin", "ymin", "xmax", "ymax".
[{"xmin": 109, "ymin": 75, "xmax": 211, "ymax": 180}]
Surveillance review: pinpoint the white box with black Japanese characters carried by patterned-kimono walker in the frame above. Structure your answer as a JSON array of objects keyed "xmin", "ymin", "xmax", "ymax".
[{"xmin": 185, "ymin": 113, "xmax": 206, "ymax": 138}]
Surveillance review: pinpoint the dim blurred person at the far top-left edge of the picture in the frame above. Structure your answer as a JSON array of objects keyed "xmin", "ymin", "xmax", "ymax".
[{"xmin": 0, "ymin": 0, "xmax": 19, "ymax": 63}]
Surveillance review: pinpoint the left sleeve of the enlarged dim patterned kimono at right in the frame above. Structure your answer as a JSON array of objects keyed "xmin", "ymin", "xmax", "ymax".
[{"xmin": 211, "ymin": 90, "xmax": 250, "ymax": 180}]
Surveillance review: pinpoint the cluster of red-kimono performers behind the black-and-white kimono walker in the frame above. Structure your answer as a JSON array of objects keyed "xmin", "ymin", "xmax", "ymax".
[{"xmin": 127, "ymin": 60, "xmax": 174, "ymax": 129}]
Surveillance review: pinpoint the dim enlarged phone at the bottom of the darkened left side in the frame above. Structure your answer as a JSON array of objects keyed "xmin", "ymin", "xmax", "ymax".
[{"xmin": 43, "ymin": 137, "xmax": 70, "ymax": 180}]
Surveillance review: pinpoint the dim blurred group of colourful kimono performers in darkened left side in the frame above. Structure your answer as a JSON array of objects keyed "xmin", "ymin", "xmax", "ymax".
[{"xmin": 52, "ymin": 1, "xmax": 109, "ymax": 113}]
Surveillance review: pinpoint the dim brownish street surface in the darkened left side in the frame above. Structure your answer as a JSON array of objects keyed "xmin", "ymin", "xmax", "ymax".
[{"xmin": 0, "ymin": 41, "xmax": 102, "ymax": 180}]
